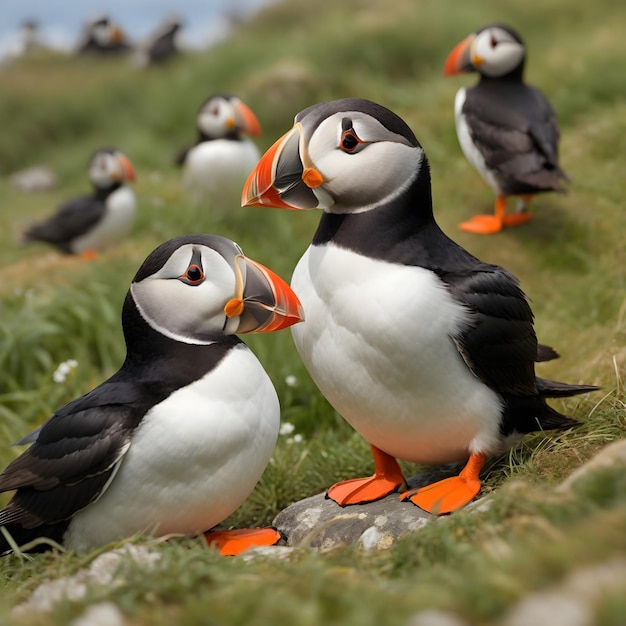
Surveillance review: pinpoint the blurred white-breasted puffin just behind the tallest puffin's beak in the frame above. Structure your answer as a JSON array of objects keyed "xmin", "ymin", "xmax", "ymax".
[{"xmin": 175, "ymin": 93, "xmax": 261, "ymax": 205}]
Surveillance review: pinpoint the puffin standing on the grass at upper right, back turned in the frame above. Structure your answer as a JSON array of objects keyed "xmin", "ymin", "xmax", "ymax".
[{"xmin": 444, "ymin": 24, "xmax": 569, "ymax": 234}]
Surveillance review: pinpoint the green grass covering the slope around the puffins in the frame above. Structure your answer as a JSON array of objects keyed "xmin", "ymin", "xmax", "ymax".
[{"xmin": 0, "ymin": 0, "xmax": 626, "ymax": 626}]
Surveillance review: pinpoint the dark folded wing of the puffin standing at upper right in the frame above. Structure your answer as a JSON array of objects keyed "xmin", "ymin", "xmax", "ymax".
[{"xmin": 463, "ymin": 83, "xmax": 568, "ymax": 193}]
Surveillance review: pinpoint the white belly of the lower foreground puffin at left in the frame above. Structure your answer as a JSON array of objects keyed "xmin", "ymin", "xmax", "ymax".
[{"xmin": 64, "ymin": 349, "xmax": 280, "ymax": 550}]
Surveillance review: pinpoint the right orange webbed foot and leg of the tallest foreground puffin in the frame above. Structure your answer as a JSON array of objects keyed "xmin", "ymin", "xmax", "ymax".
[{"xmin": 400, "ymin": 454, "xmax": 487, "ymax": 515}]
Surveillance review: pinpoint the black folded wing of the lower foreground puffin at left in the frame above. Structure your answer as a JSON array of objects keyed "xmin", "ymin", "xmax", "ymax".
[{"xmin": 0, "ymin": 382, "xmax": 149, "ymax": 528}]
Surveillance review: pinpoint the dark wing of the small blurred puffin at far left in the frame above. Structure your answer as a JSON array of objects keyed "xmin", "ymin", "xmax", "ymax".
[{"xmin": 24, "ymin": 196, "xmax": 106, "ymax": 252}]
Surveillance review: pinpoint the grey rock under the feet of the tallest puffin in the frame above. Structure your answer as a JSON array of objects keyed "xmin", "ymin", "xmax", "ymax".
[{"xmin": 273, "ymin": 464, "xmax": 462, "ymax": 551}]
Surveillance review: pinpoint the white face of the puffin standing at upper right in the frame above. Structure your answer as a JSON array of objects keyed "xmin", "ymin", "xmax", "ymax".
[{"xmin": 471, "ymin": 26, "xmax": 525, "ymax": 78}]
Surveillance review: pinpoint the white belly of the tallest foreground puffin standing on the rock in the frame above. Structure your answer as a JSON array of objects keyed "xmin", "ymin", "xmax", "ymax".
[{"xmin": 292, "ymin": 245, "xmax": 501, "ymax": 463}]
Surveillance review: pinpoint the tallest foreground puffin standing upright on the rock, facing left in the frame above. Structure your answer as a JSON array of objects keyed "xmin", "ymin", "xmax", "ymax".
[{"xmin": 242, "ymin": 98, "xmax": 597, "ymax": 514}]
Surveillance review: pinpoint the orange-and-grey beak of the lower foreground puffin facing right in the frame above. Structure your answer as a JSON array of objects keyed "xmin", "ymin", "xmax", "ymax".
[{"xmin": 229, "ymin": 255, "xmax": 304, "ymax": 334}]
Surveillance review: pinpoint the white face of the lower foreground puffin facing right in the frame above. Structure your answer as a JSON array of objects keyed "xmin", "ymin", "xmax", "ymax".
[{"xmin": 130, "ymin": 244, "xmax": 240, "ymax": 344}]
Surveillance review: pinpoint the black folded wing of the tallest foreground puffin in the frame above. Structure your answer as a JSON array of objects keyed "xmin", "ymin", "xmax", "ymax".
[{"xmin": 442, "ymin": 264, "xmax": 540, "ymax": 396}]
